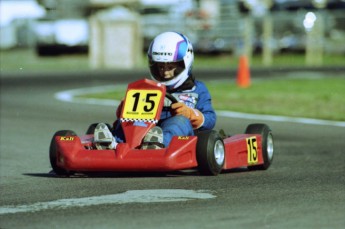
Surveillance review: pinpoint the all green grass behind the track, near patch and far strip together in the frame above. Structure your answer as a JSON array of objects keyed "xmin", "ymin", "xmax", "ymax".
[{"xmin": 0, "ymin": 49, "xmax": 345, "ymax": 121}]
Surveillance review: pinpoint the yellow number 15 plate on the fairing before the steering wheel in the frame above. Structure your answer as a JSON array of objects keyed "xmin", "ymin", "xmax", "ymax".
[{"xmin": 122, "ymin": 89, "xmax": 162, "ymax": 120}]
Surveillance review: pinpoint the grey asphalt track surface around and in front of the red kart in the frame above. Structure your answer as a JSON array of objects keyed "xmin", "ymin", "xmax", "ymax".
[{"xmin": 0, "ymin": 72, "xmax": 345, "ymax": 229}]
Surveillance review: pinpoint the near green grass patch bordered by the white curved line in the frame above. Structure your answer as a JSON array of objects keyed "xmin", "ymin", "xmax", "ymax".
[{"xmin": 78, "ymin": 77, "xmax": 345, "ymax": 121}]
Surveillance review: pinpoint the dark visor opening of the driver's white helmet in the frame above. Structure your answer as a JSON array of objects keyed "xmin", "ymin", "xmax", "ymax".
[{"xmin": 149, "ymin": 60, "xmax": 186, "ymax": 82}]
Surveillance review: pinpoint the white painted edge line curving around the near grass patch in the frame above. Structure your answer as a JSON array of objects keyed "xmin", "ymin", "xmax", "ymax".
[{"xmin": 55, "ymin": 85, "xmax": 345, "ymax": 127}]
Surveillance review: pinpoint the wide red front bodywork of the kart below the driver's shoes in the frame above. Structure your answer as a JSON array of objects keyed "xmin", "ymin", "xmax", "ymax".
[{"xmin": 56, "ymin": 136, "xmax": 197, "ymax": 171}]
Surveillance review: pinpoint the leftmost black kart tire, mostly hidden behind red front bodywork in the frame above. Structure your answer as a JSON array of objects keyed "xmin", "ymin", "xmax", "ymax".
[{"xmin": 49, "ymin": 130, "xmax": 77, "ymax": 176}]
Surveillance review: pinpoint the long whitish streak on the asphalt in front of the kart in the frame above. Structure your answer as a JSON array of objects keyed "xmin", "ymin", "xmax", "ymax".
[{"xmin": 0, "ymin": 189, "xmax": 216, "ymax": 215}]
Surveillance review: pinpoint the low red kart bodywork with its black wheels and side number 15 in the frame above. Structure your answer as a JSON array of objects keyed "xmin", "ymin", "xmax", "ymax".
[{"xmin": 50, "ymin": 124, "xmax": 273, "ymax": 175}]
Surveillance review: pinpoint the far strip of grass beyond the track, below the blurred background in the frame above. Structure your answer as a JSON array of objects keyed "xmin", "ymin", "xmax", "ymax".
[{"xmin": 0, "ymin": 49, "xmax": 345, "ymax": 73}]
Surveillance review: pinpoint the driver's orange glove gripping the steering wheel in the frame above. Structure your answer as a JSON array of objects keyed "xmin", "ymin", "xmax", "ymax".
[{"xmin": 171, "ymin": 102, "xmax": 204, "ymax": 129}]
